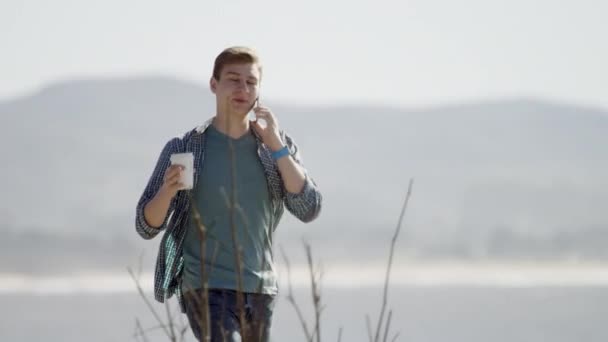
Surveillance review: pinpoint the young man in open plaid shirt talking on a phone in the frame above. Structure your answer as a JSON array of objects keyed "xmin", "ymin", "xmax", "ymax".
[{"xmin": 136, "ymin": 47, "xmax": 322, "ymax": 341}]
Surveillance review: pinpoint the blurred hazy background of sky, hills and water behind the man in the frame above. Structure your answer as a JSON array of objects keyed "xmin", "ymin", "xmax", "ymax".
[{"xmin": 0, "ymin": 0, "xmax": 608, "ymax": 341}]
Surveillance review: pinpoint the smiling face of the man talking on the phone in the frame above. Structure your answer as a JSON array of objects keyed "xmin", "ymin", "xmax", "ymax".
[{"xmin": 210, "ymin": 63, "xmax": 260, "ymax": 114}]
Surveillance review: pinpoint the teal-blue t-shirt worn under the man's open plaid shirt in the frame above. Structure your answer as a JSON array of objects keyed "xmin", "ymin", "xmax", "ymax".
[{"xmin": 182, "ymin": 125, "xmax": 278, "ymax": 294}]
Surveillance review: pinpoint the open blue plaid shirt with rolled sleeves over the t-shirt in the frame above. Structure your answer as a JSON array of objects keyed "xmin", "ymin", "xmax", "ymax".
[{"xmin": 135, "ymin": 119, "xmax": 322, "ymax": 312}]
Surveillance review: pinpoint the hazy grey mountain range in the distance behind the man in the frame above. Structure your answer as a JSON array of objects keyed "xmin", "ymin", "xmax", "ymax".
[{"xmin": 0, "ymin": 77, "xmax": 608, "ymax": 271}]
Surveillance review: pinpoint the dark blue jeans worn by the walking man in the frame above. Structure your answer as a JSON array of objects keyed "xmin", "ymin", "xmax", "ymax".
[{"xmin": 184, "ymin": 289, "xmax": 275, "ymax": 342}]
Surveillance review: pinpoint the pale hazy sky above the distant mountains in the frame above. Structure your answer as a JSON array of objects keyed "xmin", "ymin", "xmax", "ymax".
[{"xmin": 0, "ymin": 0, "xmax": 608, "ymax": 107}]
